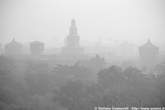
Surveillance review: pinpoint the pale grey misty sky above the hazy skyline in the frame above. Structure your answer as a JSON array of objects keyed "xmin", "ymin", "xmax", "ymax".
[{"xmin": 0, "ymin": 0, "xmax": 165, "ymax": 47}]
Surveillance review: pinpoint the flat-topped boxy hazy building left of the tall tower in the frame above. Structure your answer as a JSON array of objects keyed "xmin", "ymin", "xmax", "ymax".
[{"xmin": 30, "ymin": 41, "xmax": 44, "ymax": 55}]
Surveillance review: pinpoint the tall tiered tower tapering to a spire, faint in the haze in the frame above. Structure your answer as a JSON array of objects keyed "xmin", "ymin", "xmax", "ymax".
[{"xmin": 61, "ymin": 19, "xmax": 83, "ymax": 62}]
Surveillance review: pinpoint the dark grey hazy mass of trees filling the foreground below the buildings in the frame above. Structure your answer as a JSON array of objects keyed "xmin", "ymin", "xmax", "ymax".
[{"xmin": 0, "ymin": 56, "xmax": 165, "ymax": 110}]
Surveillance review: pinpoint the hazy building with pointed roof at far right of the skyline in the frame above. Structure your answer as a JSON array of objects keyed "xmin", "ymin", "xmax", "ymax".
[{"xmin": 139, "ymin": 40, "xmax": 159, "ymax": 69}]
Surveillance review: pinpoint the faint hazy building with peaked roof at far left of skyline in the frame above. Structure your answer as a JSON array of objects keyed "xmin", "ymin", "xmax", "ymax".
[{"xmin": 5, "ymin": 38, "xmax": 23, "ymax": 56}]
